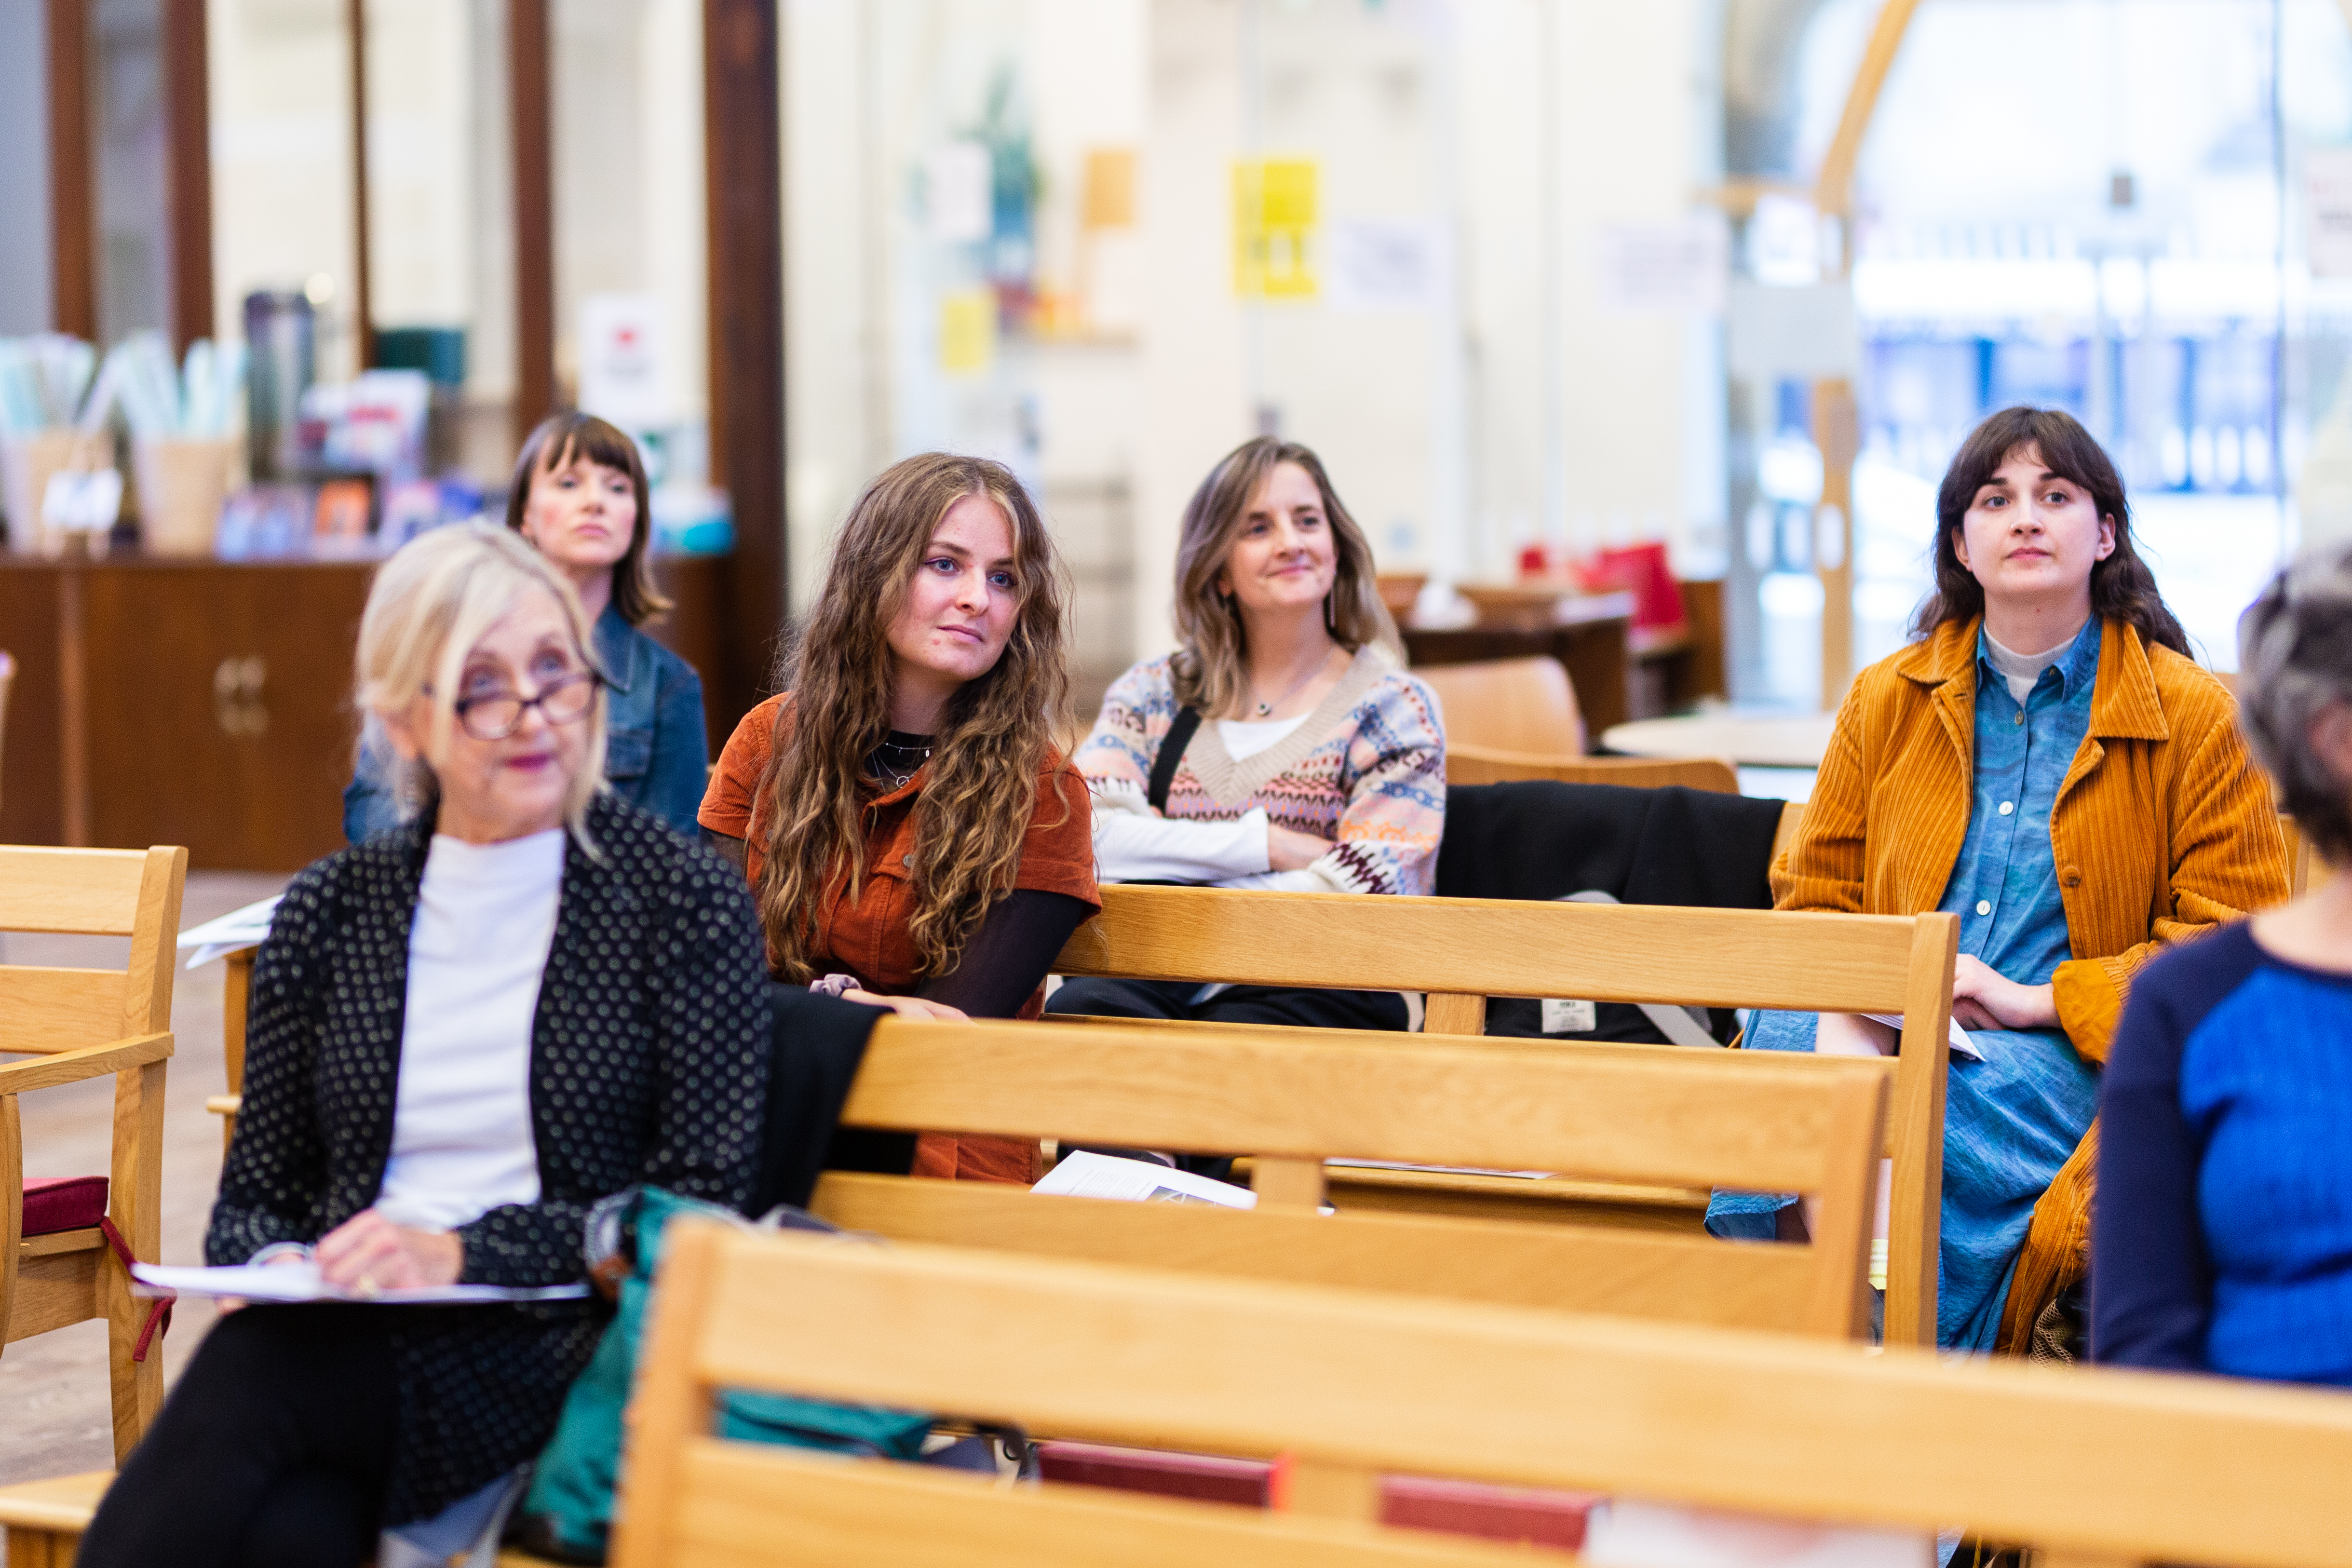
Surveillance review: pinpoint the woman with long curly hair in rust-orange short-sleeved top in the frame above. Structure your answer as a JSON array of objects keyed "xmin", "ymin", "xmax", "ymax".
[{"xmin": 701, "ymin": 451, "xmax": 1101, "ymax": 1182}]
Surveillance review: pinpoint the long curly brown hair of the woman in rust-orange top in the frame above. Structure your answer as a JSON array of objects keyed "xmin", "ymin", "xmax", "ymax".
[{"xmin": 757, "ymin": 451, "xmax": 1070, "ymax": 980}]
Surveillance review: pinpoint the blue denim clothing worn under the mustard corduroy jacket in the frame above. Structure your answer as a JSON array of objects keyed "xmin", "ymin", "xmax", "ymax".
[{"xmin": 1707, "ymin": 616, "xmax": 2100, "ymax": 1350}]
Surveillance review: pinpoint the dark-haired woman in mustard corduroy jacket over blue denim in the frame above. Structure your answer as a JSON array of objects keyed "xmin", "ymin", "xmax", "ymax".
[{"xmin": 1710, "ymin": 409, "xmax": 2286, "ymax": 1354}]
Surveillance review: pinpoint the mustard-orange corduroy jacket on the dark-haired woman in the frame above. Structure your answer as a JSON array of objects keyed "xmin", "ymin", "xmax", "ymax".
[{"xmin": 1771, "ymin": 621, "xmax": 2288, "ymax": 1350}]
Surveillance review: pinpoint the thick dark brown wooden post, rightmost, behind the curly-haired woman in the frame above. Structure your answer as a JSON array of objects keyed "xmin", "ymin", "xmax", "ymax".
[{"xmin": 703, "ymin": 0, "xmax": 788, "ymax": 712}]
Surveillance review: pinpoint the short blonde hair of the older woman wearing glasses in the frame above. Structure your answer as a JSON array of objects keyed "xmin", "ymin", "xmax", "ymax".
[{"xmin": 353, "ymin": 524, "xmax": 605, "ymax": 849}]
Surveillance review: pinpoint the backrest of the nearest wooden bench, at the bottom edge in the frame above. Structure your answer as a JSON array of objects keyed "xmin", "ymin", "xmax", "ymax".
[{"xmin": 630, "ymin": 1225, "xmax": 2352, "ymax": 1568}]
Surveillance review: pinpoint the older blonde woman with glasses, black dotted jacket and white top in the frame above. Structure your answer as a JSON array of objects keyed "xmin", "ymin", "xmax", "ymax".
[{"xmin": 80, "ymin": 527, "xmax": 769, "ymax": 1568}]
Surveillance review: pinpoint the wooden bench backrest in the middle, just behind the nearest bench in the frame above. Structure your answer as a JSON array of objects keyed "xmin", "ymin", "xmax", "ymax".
[{"xmin": 811, "ymin": 1018, "xmax": 1891, "ymax": 1338}]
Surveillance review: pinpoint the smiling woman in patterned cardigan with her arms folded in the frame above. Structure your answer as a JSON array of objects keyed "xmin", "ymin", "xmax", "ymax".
[{"xmin": 1054, "ymin": 437, "xmax": 1446, "ymax": 1029}]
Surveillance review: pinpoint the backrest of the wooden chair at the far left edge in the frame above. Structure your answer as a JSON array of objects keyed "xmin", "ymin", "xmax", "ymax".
[{"xmin": 0, "ymin": 846, "xmax": 188, "ymax": 1053}]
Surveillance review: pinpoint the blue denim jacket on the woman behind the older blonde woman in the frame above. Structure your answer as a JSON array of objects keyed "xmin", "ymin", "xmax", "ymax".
[{"xmin": 343, "ymin": 604, "xmax": 710, "ymax": 844}]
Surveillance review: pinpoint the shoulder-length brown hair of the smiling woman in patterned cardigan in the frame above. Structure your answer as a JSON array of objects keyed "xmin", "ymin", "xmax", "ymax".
[{"xmin": 1169, "ymin": 435, "xmax": 1404, "ymax": 717}]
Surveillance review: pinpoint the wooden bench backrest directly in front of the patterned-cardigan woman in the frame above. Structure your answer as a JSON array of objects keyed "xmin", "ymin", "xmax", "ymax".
[{"xmin": 1054, "ymin": 886, "xmax": 1959, "ymax": 1345}]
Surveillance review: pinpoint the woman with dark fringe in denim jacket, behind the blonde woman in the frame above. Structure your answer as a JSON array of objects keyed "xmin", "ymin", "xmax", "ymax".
[{"xmin": 343, "ymin": 411, "xmax": 710, "ymax": 844}]
